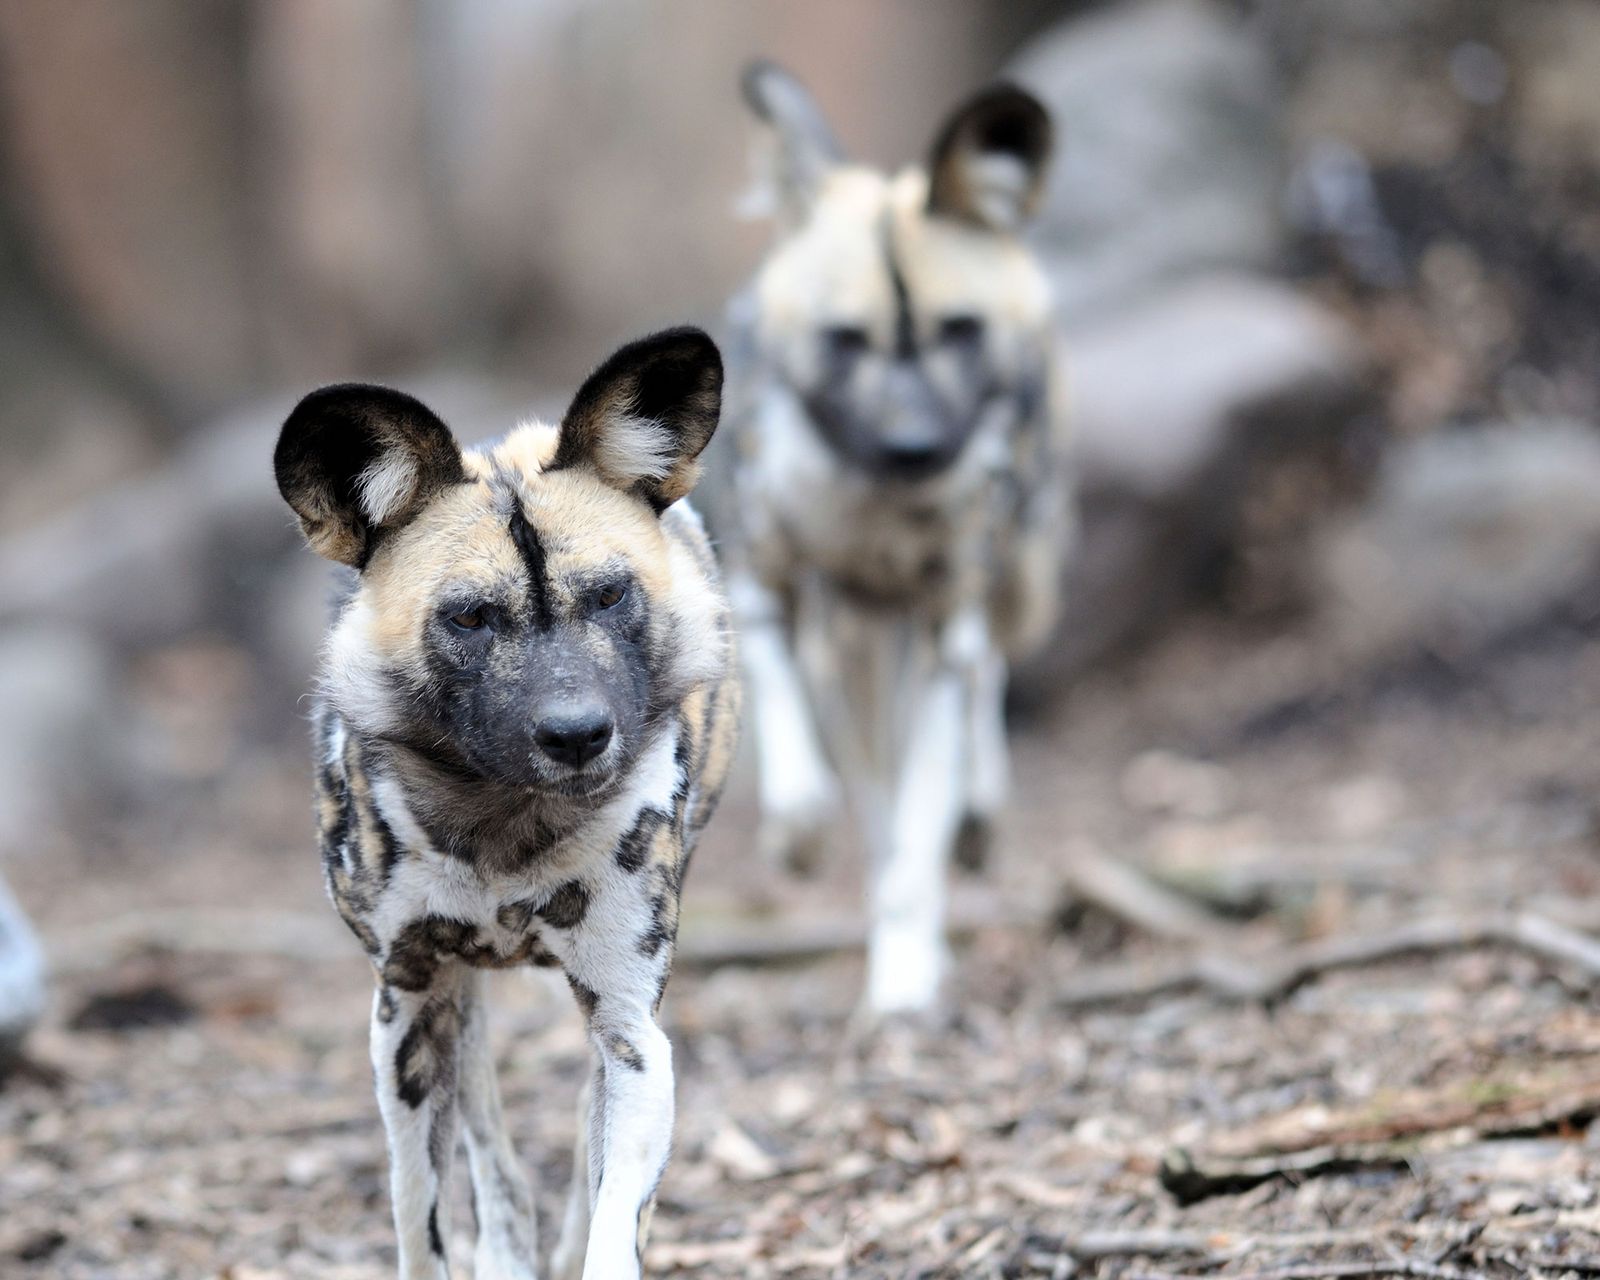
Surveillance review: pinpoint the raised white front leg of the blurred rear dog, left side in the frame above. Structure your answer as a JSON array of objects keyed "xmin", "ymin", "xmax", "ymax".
[{"xmin": 733, "ymin": 579, "xmax": 840, "ymax": 870}]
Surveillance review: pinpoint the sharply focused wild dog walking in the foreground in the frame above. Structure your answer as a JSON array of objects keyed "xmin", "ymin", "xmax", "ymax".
[{"xmin": 274, "ymin": 330, "xmax": 739, "ymax": 1280}]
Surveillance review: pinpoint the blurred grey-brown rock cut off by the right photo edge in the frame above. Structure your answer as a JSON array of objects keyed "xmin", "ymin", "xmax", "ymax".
[{"xmin": 1315, "ymin": 421, "xmax": 1600, "ymax": 658}]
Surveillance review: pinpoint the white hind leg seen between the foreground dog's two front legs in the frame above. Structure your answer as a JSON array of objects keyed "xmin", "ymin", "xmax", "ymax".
[{"xmin": 458, "ymin": 973, "xmax": 539, "ymax": 1280}]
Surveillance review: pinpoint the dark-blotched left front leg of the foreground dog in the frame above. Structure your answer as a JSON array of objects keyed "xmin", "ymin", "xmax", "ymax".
[{"xmin": 371, "ymin": 966, "xmax": 461, "ymax": 1280}]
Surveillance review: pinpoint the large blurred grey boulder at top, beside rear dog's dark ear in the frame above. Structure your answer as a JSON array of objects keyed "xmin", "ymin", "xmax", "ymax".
[{"xmin": 1008, "ymin": 0, "xmax": 1282, "ymax": 320}]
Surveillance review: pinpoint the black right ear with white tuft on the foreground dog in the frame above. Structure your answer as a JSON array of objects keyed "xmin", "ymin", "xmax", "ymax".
[{"xmin": 546, "ymin": 328, "xmax": 722, "ymax": 512}]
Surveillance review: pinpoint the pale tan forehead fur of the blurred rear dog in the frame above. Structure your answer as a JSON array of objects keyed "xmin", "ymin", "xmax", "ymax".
[{"xmin": 755, "ymin": 165, "xmax": 1050, "ymax": 341}]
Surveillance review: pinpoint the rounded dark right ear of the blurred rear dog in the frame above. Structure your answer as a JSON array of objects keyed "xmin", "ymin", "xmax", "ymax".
[{"xmin": 928, "ymin": 85, "xmax": 1053, "ymax": 232}]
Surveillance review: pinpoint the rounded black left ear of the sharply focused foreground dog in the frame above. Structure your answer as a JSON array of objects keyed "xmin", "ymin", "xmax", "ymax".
[{"xmin": 272, "ymin": 382, "xmax": 467, "ymax": 568}]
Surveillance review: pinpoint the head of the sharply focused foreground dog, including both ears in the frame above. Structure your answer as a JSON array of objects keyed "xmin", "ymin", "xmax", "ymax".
[{"xmin": 274, "ymin": 330, "xmax": 725, "ymax": 797}]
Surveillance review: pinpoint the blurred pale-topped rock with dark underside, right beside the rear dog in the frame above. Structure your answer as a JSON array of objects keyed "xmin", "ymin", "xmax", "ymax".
[{"xmin": 1024, "ymin": 275, "xmax": 1368, "ymax": 690}]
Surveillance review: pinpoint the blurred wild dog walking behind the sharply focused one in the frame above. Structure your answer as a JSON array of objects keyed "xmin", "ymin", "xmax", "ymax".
[{"xmin": 730, "ymin": 62, "xmax": 1070, "ymax": 1013}]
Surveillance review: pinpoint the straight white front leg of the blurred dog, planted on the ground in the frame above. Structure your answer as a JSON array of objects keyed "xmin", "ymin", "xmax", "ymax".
[{"xmin": 867, "ymin": 664, "xmax": 963, "ymax": 1014}]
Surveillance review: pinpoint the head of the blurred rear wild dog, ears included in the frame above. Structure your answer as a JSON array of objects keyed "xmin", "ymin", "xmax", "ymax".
[{"xmin": 744, "ymin": 62, "xmax": 1051, "ymax": 480}]
